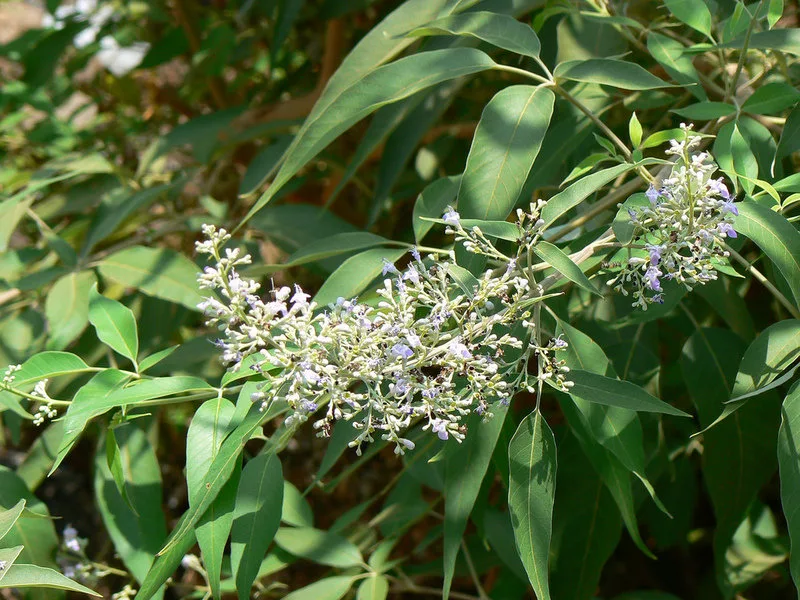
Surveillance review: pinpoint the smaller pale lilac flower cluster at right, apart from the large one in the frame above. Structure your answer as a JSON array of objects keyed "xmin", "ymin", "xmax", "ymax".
[{"xmin": 608, "ymin": 124, "xmax": 739, "ymax": 310}]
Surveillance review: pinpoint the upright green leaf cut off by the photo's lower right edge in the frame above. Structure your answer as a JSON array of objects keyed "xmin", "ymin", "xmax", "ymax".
[{"xmin": 778, "ymin": 382, "xmax": 800, "ymax": 589}]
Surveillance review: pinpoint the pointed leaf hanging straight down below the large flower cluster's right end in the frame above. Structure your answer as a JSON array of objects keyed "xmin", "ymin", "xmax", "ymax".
[{"xmin": 508, "ymin": 410, "xmax": 557, "ymax": 600}]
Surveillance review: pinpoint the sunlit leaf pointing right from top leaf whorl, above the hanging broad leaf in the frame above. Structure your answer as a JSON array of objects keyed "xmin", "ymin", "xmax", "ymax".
[{"xmin": 553, "ymin": 58, "xmax": 675, "ymax": 90}]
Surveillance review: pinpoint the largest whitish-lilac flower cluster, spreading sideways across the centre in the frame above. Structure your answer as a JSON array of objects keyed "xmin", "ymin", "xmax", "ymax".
[{"xmin": 197, "ymin": 213, "xmax": 569, "ymax": 454}]
